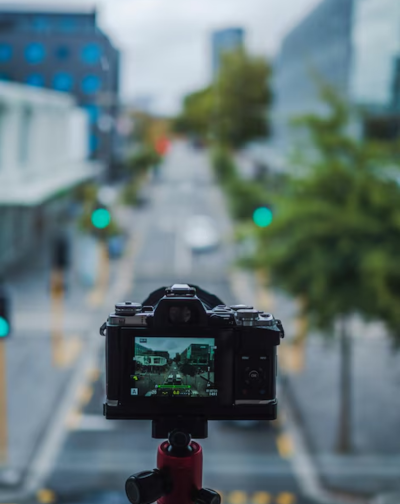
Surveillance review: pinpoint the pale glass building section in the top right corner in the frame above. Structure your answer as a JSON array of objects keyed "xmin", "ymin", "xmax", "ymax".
[{"xmin": 350, "ymin": 0, "xmax": 400, "ymax": 138}]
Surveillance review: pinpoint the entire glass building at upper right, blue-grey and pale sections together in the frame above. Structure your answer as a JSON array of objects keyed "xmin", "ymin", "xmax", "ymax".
[{"xmin": 272, "ymin": 0, "xmax": 400, "ymax": 152}]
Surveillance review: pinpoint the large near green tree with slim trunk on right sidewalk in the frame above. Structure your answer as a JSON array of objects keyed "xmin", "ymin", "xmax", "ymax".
[{"xmin": 253, "ymin": 89, "xmax": 400, "ymax": 452}]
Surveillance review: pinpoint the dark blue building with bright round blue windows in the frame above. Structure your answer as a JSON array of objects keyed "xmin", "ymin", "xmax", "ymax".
[{"xmin": 0, "ymin": 5, "xmax": 120, "ymax": 164}]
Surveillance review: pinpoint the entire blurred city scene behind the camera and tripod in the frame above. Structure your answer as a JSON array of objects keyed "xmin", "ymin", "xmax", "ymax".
[{"xmin": 0, "ymin": 0, "xmax": 400, "ymax": 504}]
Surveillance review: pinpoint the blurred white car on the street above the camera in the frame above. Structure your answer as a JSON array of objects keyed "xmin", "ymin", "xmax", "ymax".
[{"xmin": 184, "ymin": 215, "xmax": 220, "ymax": 252}]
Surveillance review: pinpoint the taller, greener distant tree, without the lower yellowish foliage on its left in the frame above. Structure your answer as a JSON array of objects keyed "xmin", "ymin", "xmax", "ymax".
[{"xmin": 212, "ymin": 49, "xmax": 272, "ymax": 148}]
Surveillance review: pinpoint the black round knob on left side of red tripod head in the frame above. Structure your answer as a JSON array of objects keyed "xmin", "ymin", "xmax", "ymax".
[{"xmin": 125, "ymin": 469, "xmax": 168, "ymax": 504}]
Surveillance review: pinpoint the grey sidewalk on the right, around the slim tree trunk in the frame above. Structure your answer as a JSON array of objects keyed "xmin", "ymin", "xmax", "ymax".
[{"xmin": 233, "ymin": 272, "xmax": 400, "ymax": 502}]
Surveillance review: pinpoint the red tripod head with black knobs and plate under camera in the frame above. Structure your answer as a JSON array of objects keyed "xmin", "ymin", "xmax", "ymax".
[{"xmin": 125, "ymin": 417, "xmax": 221, "ymax": 504}]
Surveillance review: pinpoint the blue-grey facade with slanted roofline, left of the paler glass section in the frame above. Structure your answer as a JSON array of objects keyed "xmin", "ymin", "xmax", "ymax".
[{"xmin": 272, "ymin": 0, "xmax": 353, "ymax": 152}]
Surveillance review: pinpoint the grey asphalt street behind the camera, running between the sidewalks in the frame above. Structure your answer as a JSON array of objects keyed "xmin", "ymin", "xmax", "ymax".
[{"xmin": 25, "ymin": 143, "xmax": 311, "ymax": 504}]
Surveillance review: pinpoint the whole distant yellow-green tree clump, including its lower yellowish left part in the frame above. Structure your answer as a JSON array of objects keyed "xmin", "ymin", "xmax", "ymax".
[{"xmin": 174, "ymin": 49, "xmax": 272, "ymax": 148}]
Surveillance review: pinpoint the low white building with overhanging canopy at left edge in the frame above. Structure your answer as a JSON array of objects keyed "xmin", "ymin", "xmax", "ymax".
[{"xmin": 0, "ymin": 82, "xmax": 100, "ymax": 275}]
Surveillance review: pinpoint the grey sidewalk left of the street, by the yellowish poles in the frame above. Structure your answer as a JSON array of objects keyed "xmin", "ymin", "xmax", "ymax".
[{"xmin": 0, "ymin": 202, "xmax": 142, "ymax": 496}]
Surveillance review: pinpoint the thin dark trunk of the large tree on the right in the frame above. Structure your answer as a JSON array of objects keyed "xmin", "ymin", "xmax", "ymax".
[{"xmin": 336, "ymin": 317, "xmax": 352, "ymax": 453}]
